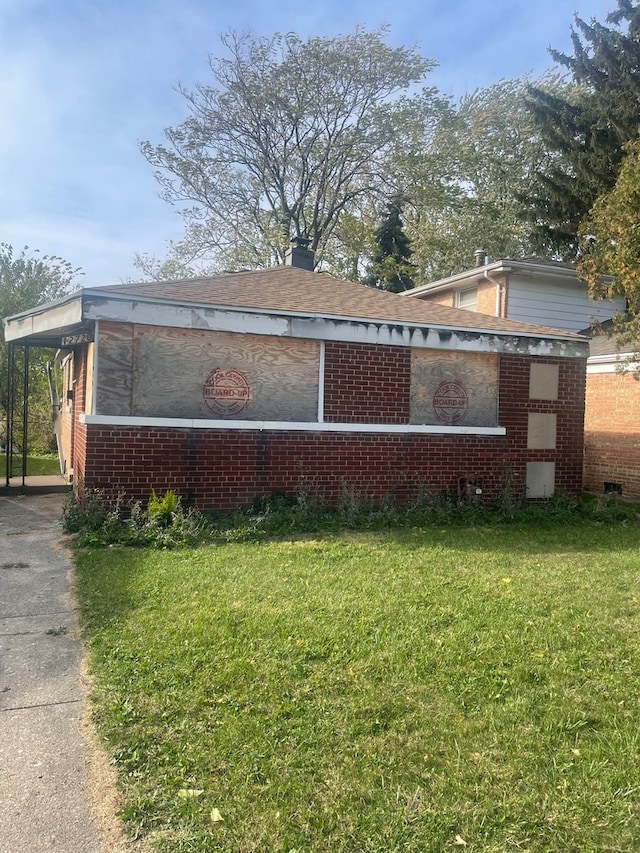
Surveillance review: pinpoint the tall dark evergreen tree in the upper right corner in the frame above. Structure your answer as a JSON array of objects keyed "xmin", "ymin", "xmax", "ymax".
[{"xmin": 527, "ymin": 0, "xmax": 640, "ymax": 260}]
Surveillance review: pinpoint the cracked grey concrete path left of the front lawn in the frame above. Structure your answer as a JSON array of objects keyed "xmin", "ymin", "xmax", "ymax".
[{"xmin": 0, "ymin": 494, "xmax": 120, "ymax": 853}]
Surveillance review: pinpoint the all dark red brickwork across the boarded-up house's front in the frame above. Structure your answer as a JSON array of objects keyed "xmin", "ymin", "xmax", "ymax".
[{"xmin": 76, "ymin": 345, "xmax": 584, "ymax": 510}]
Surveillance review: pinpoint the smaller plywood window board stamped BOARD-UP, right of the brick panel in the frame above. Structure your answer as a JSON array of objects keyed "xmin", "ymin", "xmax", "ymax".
[{"xmin": 411, "ymin": 349, "xmax": 498, "ymax": 426}]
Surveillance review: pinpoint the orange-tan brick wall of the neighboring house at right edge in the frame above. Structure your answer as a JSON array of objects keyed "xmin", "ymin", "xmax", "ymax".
[{"xmin": 584, "ymin": 373, "xmax": 640, "ymax": 497}]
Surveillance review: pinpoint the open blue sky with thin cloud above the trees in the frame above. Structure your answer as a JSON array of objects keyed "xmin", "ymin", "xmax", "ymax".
[{"xmin": 0, "ymin": 0, "xmax": 615, "ymax": 286}]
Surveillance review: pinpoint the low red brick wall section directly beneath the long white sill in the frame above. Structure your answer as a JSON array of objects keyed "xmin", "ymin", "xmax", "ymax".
[{"xmin": 80, "ymin": 427, "xmax": 507, "ymax": 510}]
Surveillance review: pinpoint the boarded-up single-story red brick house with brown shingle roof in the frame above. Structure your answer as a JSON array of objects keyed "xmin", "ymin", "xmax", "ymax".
[{"xmin": 5, "ymin": 243, "xmax": 588, "ymax": 510}]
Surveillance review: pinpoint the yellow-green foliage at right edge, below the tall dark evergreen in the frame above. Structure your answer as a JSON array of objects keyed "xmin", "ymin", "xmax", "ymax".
[{"xmin": 578, "ymin": 141, "xmax": 640, "ymax": 352}]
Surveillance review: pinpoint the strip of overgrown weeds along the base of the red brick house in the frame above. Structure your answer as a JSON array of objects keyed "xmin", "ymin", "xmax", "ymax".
[{"xmin": 63, "ymin": 482, "xmax": 639, "ymax": 548}]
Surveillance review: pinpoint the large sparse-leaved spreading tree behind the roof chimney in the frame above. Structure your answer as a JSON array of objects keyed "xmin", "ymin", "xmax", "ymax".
[{"xmin": 141, "ymin": 28, "xmax": 446, "ymax": 270}]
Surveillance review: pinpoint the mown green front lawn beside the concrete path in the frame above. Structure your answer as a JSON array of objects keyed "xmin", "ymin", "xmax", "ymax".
[{"xmin": 76, "ymin": 524, "xmax": 640, "ymax": 853}]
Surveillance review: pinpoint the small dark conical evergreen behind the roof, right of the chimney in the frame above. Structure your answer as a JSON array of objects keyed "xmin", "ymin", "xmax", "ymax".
[{"xmin": 364, "ymin": 196, "xmax": 415, "ymax": 293}]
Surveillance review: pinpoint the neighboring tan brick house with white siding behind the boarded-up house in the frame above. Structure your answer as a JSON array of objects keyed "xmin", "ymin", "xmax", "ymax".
[{"xmin": 402, "ymin": 252, "xmax": 640, "ymax": 497}]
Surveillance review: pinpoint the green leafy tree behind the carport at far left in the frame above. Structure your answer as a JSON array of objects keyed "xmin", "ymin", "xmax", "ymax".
[{"xmin": 0, "ymin": 243, "xmax": 80, "ymax": 450}]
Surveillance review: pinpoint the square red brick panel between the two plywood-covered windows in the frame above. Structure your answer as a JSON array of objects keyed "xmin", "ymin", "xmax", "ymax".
[{"xmin": 324, "ymin": 342, "xmax": 411, "ymax": 424}]
